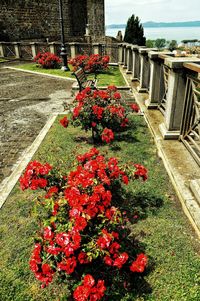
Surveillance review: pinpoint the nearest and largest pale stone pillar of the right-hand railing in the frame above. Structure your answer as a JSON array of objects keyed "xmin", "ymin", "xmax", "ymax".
[{"xmin": 159, "ymin": 57, "xmax": 200, "ymax": 139}]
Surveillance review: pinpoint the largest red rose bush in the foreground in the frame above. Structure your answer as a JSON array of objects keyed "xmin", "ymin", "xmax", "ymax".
[{"xmin": 20, "ymin": 148, "xmax": 147, "ymax": 301}]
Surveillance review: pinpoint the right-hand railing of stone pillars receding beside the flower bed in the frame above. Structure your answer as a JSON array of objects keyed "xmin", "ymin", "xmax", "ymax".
[{"xmin": 118, "ymin": 43, "xmax": 200, "ymax": 165}]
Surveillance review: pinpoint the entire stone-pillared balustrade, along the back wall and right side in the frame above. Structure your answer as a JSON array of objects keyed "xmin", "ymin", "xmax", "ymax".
[{"xmin": 0, "ymin": 42, "xmax": 200, "ymax": 163}]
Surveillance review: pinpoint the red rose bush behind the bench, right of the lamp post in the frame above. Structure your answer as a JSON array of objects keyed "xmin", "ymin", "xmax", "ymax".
[{"xmin": 69, "ymin": 54, "xmax": 110, "ymax": 73}]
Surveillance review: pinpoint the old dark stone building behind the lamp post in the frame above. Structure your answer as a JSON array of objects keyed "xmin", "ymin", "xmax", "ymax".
[{"xmin": 0, "ymin": 0, "xmax": 105, "ymax": 42}]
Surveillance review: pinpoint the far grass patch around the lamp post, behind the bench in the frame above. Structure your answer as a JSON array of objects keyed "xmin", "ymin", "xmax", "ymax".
[{"xmin": 16, "ymin": 63, "xmax": 126, "ymax": 86}]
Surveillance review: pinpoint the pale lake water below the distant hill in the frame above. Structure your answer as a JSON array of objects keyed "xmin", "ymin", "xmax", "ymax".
[{"xmin": 106, "ymin": 27, "xmax": 200, "ymax": 43}]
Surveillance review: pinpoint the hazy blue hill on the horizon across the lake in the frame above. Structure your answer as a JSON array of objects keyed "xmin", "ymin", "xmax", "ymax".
[{"xmin": 106, "ymin": 21, "xmax": 200, "ymax": 28}]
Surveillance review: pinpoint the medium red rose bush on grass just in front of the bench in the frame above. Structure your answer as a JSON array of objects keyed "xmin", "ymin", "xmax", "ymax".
[{"xmin": 61, "ymin": 86, "xmax": 137, "ymax": 143}]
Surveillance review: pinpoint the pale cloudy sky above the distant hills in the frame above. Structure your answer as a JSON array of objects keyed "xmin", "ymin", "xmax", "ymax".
[{"xmin": 105, "ymin": 0, "xmax": 200, "ymax": 24}]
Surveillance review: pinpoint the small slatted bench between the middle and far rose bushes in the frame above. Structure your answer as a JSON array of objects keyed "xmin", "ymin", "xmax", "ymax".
[{"xmin": 72, "ymin": 67, "xmax": 97, "ymax": 91}]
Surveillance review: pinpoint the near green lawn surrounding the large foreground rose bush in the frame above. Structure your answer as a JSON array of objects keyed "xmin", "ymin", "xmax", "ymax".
[{"xmin": 0, "ymin": 116, "xmax": 200, "ymax": 301}]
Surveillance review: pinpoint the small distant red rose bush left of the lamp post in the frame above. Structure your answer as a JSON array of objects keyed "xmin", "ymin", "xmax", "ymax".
[{"xmin": 34, "ymin": 52, "xmax": 61, "ymax": 69}]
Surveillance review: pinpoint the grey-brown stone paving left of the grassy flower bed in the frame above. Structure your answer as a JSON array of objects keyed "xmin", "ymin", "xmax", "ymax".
[{"xmin": 0, "ymin": 68, "xmax": 73, "ymax": 182}]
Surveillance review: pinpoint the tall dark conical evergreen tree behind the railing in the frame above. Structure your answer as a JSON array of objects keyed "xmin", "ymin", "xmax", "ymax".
[{"xmin": 124, "ymin": 15, "xmax": 146, "ymax": 46}]
